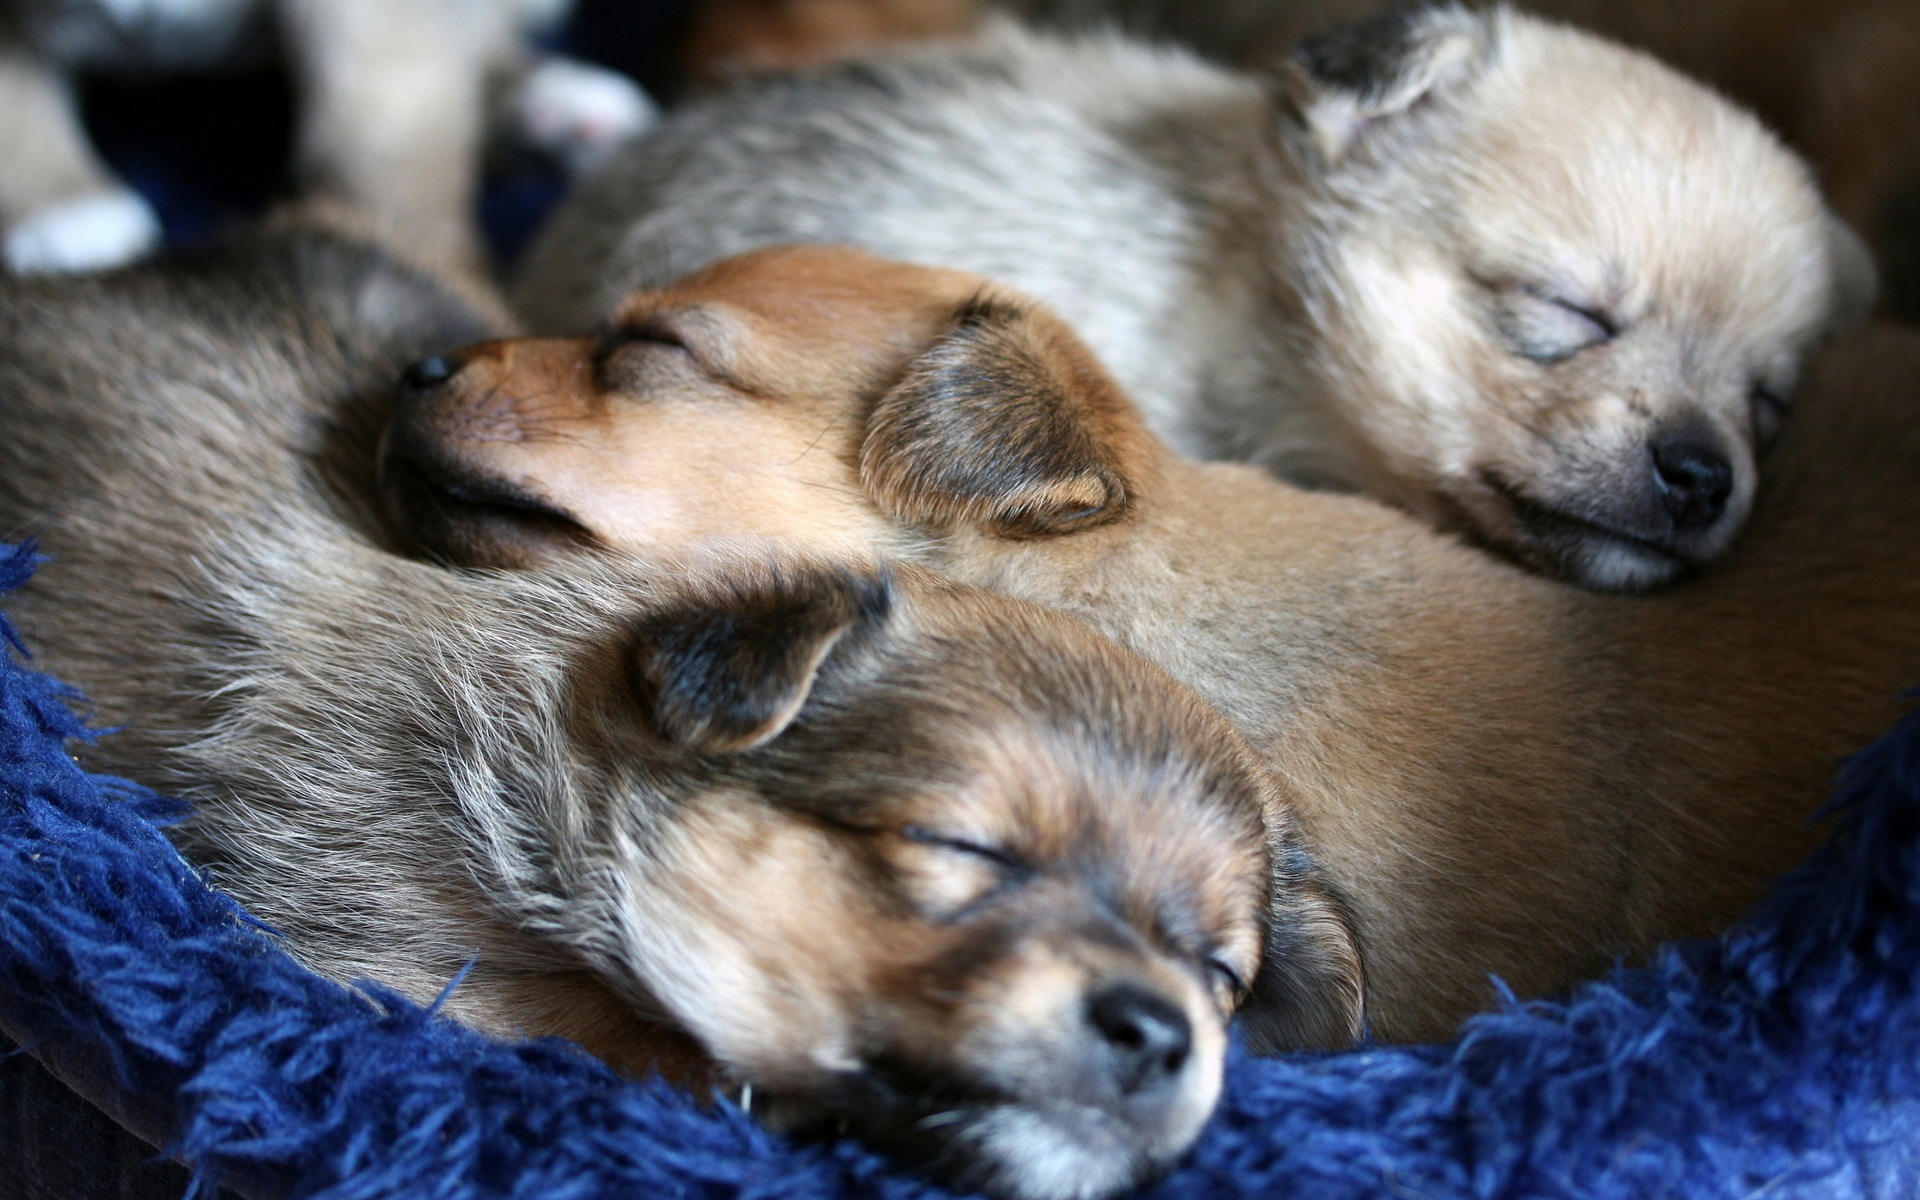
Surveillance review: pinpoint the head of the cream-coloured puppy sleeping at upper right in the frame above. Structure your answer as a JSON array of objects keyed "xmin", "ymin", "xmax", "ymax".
[{"xmin": 1283, "ymin": 8, "xmax": 1874, "ymax": 589}]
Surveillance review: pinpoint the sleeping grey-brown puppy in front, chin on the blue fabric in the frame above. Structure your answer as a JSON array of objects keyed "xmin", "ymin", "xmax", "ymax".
[{"xmin": 0, "ymin": 236, "xmax": 1361, "ymax": 1200}]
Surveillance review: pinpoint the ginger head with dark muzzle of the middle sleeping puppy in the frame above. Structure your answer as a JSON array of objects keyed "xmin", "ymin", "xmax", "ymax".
[{"xmin": 382, "ymin": 246, "xmax": 1150, "ymax": 566}]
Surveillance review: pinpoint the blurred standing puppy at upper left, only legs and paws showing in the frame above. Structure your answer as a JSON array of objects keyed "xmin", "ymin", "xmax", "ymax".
[{"xmin": 0, "ymin": 0, "xmax": 653, "ymax": 275}]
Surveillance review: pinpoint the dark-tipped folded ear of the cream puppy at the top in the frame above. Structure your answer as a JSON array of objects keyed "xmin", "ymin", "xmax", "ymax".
[{"xmin": 1281, "ymin": 4, "xmax": 1503, "ymax": 165}]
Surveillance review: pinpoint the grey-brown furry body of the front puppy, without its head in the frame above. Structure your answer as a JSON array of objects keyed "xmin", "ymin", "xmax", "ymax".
[{"xmin": 0, "ymin": 229, "xmax": 637, "ymax": 1016}]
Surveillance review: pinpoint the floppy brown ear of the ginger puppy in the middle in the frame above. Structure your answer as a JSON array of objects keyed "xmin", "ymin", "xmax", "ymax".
[{"xmin": 860, "ymin": 298, "xmax": 1146, "ymax": 538}]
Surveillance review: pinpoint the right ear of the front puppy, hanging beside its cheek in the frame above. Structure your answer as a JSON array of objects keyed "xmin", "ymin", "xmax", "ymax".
[{"xmin": 1238, "ymin": 833, "xmax": 1365, "ymax": 1054}]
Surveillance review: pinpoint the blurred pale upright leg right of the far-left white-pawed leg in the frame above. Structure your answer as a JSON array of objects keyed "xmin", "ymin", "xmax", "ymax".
[{"xmin": 280, "ymin": 0, "xmax": 503, "ymax": 273}]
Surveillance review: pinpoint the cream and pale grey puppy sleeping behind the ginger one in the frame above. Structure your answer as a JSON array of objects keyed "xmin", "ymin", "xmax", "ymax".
[{"xmin": 516, "ymin": 8, "xmax": 1872, "ymax": 591}]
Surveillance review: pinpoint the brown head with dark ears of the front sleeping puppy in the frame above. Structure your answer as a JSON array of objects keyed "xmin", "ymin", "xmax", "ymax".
[{"xmin": 568, "ymin": 568, "xmax": 1359, "ymax": 1198}]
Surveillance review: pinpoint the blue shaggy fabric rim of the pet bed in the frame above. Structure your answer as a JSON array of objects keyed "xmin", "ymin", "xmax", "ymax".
[{"xmin": 0, "ymin": 537, "xmax": 1920, "ymax": 1200}]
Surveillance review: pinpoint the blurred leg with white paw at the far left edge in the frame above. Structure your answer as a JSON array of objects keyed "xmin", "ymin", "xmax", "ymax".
[{"xmin": 0, "ymin": 50, "xmax": 159, "ymax": 275}]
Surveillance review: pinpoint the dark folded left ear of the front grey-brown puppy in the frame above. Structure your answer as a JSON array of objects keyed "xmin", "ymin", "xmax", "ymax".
[{"xmin": 632, "ymin": 568, "xmax": 893, "ymax": 755}]
